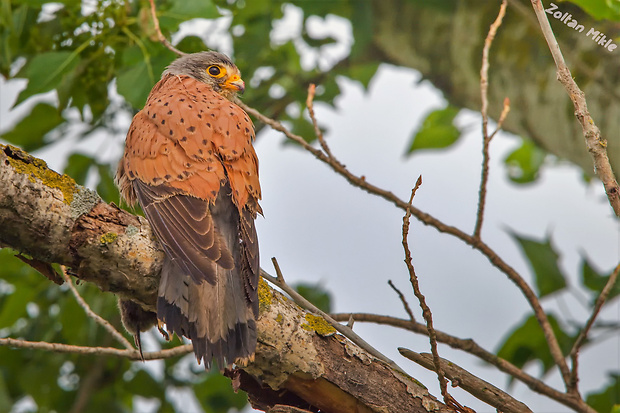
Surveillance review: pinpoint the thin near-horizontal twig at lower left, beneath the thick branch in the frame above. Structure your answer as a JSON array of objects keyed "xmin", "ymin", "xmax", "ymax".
[{"xmin": 0, "ymin": 338, "xmax": 193, "ymax": 361}]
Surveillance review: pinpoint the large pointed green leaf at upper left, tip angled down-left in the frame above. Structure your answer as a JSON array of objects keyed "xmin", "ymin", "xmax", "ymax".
[{"xmin": 15, "ymin": 51, "xmax": 79, "ymax": 105}]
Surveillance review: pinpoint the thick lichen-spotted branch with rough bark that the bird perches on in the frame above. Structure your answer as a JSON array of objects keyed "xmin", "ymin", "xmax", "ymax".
[{"xmin": 0, "ymin": 145, "xmax": 449, "ymax": 412}]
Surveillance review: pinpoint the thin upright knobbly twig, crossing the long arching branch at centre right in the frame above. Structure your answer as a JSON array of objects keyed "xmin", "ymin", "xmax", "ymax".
[{"xmin": 402, "ymin": 175, "xmax": 463, "ymax": 411}]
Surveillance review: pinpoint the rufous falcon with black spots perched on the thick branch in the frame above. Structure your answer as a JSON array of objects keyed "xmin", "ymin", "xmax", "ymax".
[{"xmin": 115, "ymin": 51, "xmax": 263, "ymax": 370}]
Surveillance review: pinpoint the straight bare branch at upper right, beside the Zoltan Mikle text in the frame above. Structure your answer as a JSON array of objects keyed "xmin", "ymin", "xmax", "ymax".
[{"xmin": 531, "ymin": 0, "xmax": 620, "ymax": 217}]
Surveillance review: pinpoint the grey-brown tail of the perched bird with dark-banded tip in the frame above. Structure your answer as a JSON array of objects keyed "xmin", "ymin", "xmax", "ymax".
[{"xmin": 157, "ymin": 257, "xmax": 256, "ymax": 370}]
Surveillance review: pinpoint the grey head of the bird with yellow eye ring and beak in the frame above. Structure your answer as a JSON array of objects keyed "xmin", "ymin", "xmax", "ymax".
[{"xmin": 162, "ymin": 52, "xmax": 245, "ymax": 99}]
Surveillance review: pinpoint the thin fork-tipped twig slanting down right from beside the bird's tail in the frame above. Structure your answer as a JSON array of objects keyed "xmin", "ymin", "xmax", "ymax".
[{"xmin": 260, "ymin": 258, "xmax": 406, "ymax": 374}]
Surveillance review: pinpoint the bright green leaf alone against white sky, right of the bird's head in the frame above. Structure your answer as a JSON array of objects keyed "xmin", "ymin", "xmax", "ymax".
[{"xmin": 407, "ymin": 106, "xmax": 461, "ymax": 155}]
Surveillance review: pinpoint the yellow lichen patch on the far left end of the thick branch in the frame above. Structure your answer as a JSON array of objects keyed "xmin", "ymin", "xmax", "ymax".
[{"xmin": 7, "ymin": 145, "xmax": 78, "ymax": 205}]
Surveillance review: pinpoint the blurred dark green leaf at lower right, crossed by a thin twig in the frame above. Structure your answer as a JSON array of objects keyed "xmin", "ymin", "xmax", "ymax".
[{"xmin": 497, "ymin": 314, "xmax": 575, "ymax": 374}]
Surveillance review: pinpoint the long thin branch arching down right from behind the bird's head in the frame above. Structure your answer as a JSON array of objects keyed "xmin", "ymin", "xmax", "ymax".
[{"xmin": 240, "ymin": 89, "xmax": 568, "ymax": 406}]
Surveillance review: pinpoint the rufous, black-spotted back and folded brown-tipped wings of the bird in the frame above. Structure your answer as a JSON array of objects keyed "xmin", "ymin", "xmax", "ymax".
[{"xmin": 117, "ymin": 75, "xmax": 260, "ymax": 287}]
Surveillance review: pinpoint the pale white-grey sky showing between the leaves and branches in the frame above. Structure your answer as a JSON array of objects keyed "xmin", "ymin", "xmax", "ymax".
[{"xmin": 0, "ymin": 5, "xmax": 620, "ymax": 412}]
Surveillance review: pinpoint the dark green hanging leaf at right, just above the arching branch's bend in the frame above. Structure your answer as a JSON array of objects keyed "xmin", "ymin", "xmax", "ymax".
[{"xmin": 510, "ymin": 233, "xmax": 566, "ymax": 297}]
